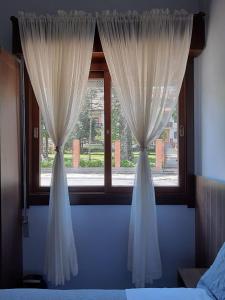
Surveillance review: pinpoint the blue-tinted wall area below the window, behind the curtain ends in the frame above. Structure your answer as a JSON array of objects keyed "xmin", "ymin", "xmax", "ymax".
[{"xmin": 23, "ymin": 205, "xmax": 195, "ymax": 289}]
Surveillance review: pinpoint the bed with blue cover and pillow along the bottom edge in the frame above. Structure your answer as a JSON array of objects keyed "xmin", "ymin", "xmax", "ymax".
[{"xmin": 0, "ymin": 225, "xmax": 221, "ymax": 300}]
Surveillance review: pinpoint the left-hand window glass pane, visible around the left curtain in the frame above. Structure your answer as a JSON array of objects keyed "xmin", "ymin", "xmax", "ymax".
[{"xmin": 40, "ymin": 79, "xmax": 104, "ymax": 186}]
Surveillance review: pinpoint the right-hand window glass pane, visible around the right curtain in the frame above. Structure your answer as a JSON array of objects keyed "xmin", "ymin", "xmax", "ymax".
[{"xmin": 111, "ymin": 87, "xmax": 179, "ymax": 186}]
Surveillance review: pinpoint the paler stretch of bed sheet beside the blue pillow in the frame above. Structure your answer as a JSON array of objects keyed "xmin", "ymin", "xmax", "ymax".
[{"xmin": 126, "ymin": 288, "xmax": 214, "ymax": 300}]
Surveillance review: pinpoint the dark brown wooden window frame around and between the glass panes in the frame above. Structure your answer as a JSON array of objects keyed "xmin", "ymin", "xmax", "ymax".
[{"xmin": 11, "ymin": 13, "xmax": 205, "ymax": 207}]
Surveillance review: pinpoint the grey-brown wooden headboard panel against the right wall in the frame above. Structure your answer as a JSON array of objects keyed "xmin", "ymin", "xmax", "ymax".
[{"xmin": 196, "ymin": 177, "xmax": 225, "ymax": 267}]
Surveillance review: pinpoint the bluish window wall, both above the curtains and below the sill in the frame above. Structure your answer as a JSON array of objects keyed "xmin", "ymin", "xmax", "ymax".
[{"xmin": 0, "ymin": 0, "xmax": 199, "ymax": 288}]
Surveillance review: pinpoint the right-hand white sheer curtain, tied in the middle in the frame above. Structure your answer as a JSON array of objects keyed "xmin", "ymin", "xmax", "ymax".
[{"xmin": 97, "ymin": 10, "xmax": 192, "ymax": 287}]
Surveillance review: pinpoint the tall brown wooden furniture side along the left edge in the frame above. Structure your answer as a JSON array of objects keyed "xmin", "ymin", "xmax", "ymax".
[{"xmin": 0, "ymin": 50, "xmax": 22, "ymax": 288}]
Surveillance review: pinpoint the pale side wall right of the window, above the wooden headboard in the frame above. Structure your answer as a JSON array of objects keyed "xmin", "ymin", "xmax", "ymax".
[{"xmin": 195, "ymin": 0, "xmax": 225, "ymax": 180}]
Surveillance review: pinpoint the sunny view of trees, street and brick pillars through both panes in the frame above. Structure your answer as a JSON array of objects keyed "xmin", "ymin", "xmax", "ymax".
[{"xmin": 40, "ymin": 79, "xmax": 179, "ymax": 186}]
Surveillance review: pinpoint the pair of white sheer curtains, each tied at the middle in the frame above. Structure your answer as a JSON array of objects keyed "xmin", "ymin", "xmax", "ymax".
[{"xmin": 19, "ymin": 10, "xmax": 193, "ymax": 287}]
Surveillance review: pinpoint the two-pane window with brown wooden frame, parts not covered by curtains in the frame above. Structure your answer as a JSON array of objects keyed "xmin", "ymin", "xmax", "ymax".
[{"xmin": 26, "ymin": 55, "xmax": 194, "ymax": 204}]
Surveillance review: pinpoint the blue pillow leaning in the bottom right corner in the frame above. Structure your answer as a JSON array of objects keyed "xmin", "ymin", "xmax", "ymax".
[{"xmin": 197, "ymin": 243, "xmax": 225, "ymax": 300}]
